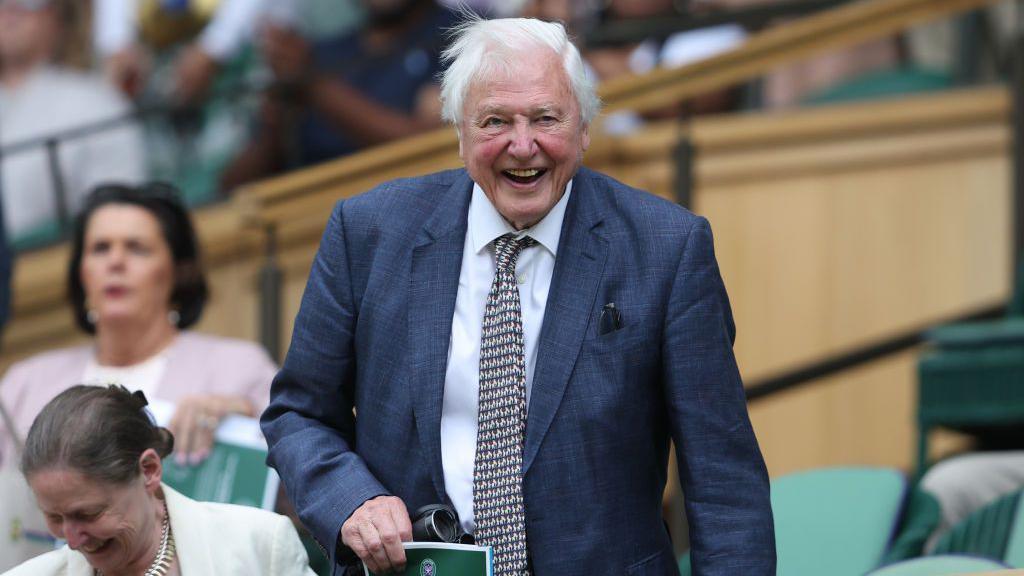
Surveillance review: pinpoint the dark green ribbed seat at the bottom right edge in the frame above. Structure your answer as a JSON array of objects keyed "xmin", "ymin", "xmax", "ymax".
[{"xmin": 933, "ymin": 485, "xmax": 1024, "ymax": 568}]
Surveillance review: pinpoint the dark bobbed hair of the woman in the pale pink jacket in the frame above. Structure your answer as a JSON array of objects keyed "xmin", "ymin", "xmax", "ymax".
[{"xmin": 68, "ymin": 182, "xmax": 208, "ymax": 334}]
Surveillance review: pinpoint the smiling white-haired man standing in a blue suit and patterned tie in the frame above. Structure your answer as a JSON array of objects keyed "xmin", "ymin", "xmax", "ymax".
[{"xmin": 263, "ymin": 14, "xmax": 775, "ymax": 576}]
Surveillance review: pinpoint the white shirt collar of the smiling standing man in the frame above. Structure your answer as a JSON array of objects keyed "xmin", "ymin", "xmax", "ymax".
[{"xmin": 469, "ymin": 180, "xmax": 572, "ymax": 256}]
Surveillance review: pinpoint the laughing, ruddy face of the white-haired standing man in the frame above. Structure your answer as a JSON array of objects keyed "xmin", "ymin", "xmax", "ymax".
[{"xmin": 459, "ymin": 49, "xmax": 590, "ymax": 230}]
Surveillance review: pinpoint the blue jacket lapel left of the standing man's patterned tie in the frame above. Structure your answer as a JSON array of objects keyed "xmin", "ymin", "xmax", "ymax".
[{"xmin": 409, "ymin": 175, "xmax": 472, "ymax": 498}]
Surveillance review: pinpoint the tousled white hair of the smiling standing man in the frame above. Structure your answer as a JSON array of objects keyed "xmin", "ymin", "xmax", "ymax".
[{"xmin": 441, "ymin": 14, "xmax": 601, "ymax": 127}]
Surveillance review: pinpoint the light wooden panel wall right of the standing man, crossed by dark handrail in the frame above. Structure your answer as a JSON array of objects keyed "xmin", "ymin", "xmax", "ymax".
[{"xmin": 694, "ymin": 87, "xmax": 1013, "ymax": 475}]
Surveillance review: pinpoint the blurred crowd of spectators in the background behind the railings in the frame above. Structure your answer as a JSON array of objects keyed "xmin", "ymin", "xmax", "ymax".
[{"xmin": 0, "ymin": 0, "xmax": 1007, "ymax": 247}]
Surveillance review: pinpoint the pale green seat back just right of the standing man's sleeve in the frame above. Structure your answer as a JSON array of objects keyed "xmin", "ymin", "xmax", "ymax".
[{"xmin": 680, "ymin": 467, "xmax": 906, "ymax": 576}]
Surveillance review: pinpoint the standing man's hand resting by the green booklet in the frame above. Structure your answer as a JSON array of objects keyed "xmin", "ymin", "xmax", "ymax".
[{"xmin": 339, "ymin": 496, "xmax": 413, "ymax": 574}]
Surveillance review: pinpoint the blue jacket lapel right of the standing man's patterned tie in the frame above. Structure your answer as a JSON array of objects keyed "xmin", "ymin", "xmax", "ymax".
[{"xmin": 523, "ymin": 169, "xmax": 610, "ymax": 474}]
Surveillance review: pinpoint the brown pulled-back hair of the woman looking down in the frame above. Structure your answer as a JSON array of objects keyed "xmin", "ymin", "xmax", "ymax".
[{"xmin": 22, "ymin": 384, "xmax": 174, "ymax": 485}]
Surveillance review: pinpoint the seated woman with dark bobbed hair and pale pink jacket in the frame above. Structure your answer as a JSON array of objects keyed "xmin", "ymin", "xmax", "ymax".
[{"xmin": 0, "ymin": 183, "xmax": 276, "ymax": 463}]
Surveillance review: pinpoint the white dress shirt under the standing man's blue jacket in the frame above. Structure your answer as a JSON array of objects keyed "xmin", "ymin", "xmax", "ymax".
[{"xmin": 441, "ymin": 180, "xmax": 572, "ymax": 533}]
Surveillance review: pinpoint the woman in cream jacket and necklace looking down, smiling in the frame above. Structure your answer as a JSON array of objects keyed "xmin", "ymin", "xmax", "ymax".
[{"xmin": 7, "ymin": 385, "xmax": 313, "ymax": 576}]
